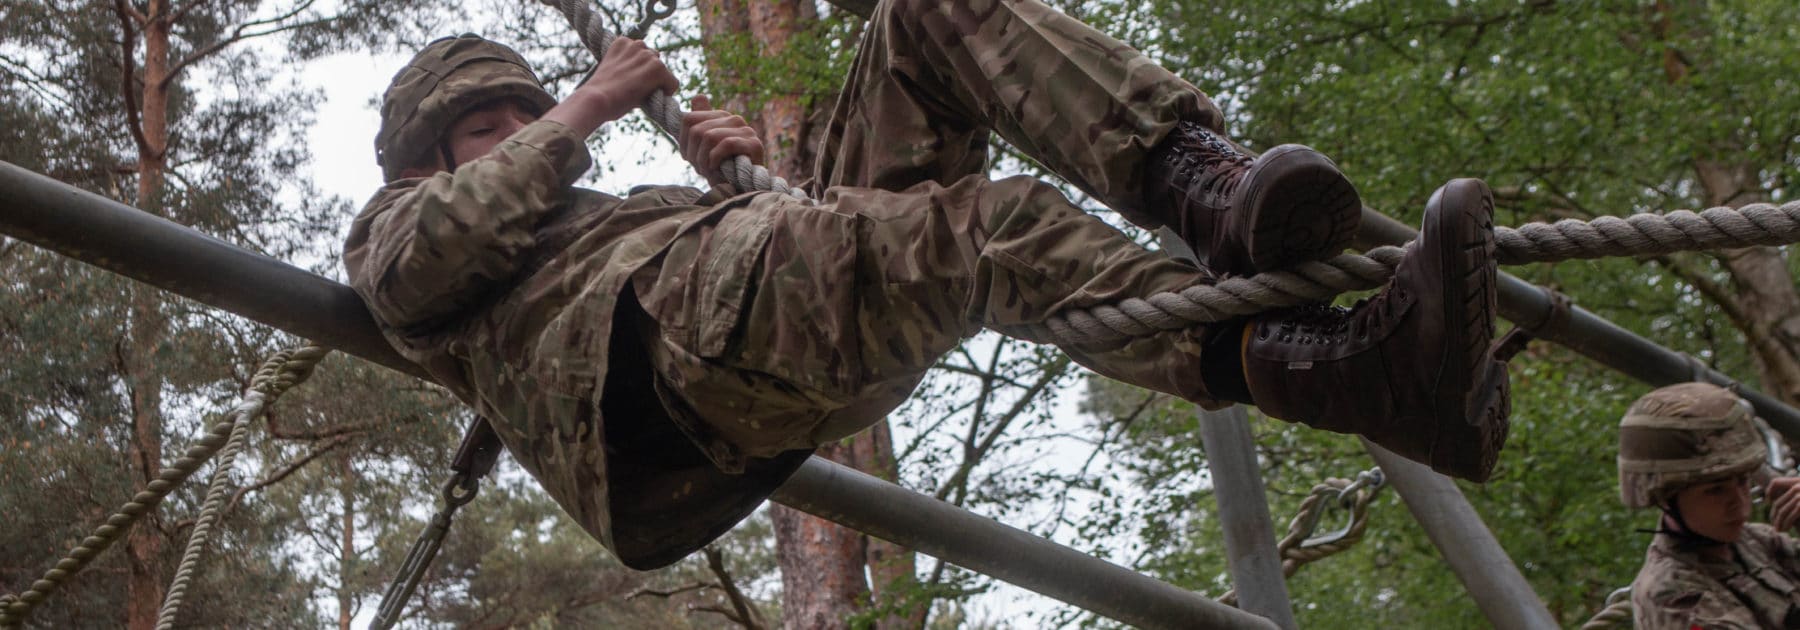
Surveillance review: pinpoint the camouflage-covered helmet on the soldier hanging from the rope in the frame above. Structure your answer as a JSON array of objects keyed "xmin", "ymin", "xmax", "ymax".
[{"xmin": 374, "ymin": 34, "xmax": 556, "ymax": 182}]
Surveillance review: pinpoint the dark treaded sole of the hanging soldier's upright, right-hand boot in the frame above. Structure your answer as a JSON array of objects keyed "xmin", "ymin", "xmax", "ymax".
[{"xmin": 1422, "ymin": 180, "xmax": 1510, "ymax": 482}]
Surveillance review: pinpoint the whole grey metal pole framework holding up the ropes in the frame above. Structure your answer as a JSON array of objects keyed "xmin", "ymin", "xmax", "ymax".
[{"xmin": 14, "ymin": 150, "xmax": 1800, "ymax": 628}]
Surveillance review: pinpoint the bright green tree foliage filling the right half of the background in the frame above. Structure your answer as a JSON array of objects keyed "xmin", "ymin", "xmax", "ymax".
[{"xmin": 1058, "ymin": 0, "xmax": 1800, "ymax": 628}]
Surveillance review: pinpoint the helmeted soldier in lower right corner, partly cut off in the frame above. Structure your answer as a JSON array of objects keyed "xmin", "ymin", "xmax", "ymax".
[{"xmin": 1618, "ymin": 383, "xmax": 1800, "ymax": 630}]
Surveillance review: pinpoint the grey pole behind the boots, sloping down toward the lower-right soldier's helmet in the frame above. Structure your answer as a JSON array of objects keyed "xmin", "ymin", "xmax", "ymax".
[{"xmin": 1357, "ymin": 207, "xmax": 1800, "ymax": 439}]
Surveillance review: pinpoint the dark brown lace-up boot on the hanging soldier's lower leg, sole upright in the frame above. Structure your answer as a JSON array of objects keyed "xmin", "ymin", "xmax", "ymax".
[{"xmin": 1244, "ymin": 180, "xmax": 1510, "ymax": 482}]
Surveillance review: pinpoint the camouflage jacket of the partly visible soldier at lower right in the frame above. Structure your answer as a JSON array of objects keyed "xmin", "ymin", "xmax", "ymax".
[{"xmin": 1631, "ymin": 524, "xmax": 1800, "ymax": 630}]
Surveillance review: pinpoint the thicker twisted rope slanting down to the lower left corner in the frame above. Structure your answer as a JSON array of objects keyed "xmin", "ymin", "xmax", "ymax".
[{"xmin": 0, "ymin": 346, "xmax": 324, "ymax": 628}]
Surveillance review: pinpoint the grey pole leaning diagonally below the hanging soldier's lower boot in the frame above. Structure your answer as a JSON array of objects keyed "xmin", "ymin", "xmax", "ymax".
[{"xmin": 1363, "ymin": 439, "xmax": 1557, "ymax": 630}]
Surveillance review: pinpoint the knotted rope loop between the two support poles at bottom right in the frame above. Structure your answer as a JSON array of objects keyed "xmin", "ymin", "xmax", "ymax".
[{"xmin": 1219, "ymin": 468, "xmax": 1386, "ymax": 607}]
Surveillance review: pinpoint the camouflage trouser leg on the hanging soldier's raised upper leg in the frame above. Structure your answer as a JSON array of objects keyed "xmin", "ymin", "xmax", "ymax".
[{"xmin": 815, "ymin": 0, "xmax": 1224, "ymax": 229}]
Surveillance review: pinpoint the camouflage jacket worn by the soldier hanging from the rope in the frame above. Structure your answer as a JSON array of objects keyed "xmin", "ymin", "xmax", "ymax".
[{"xmin": 344, "ymin": 121, "xmax": 805, "ymax": 569}]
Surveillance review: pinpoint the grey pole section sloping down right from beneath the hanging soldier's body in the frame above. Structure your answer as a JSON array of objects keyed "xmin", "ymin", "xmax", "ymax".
[{"xmin": 770, "ymin": 457, "xmax": 1276, "ymax": 628}]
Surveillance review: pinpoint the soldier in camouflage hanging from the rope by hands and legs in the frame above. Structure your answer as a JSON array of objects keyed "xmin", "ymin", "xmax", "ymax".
[{"xmin": 344, "ymin": 0, "xmax": 1507, "ymax": 567}]
